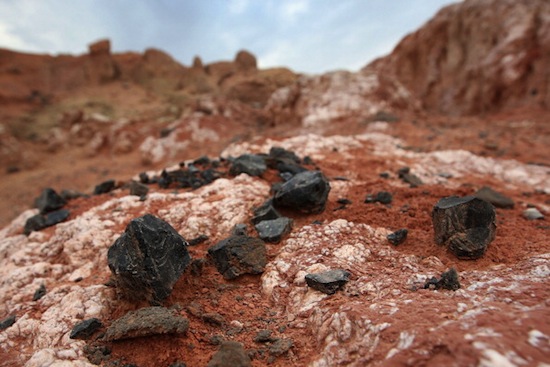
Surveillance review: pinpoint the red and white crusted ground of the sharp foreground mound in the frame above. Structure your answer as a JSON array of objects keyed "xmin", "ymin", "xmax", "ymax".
[{"xmin": 0, "ymin": 124, "xmax": 550, "ymax": 367}]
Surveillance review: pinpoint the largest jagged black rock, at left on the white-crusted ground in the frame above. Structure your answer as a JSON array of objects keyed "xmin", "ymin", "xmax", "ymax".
[{"xmin": 107, "ymin": 214, "xmax": 191, "ymax": 303}]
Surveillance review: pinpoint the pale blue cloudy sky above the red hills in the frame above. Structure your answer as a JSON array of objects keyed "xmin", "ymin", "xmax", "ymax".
[{"xmin": 0, "ymin": 0, "xmax": 456, "ymax": 73}]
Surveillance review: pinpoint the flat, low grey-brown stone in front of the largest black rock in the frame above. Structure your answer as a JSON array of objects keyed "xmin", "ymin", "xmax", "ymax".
[{"xmin": 103, "ymin": 307, "xmax": 189, "ymax": 341}]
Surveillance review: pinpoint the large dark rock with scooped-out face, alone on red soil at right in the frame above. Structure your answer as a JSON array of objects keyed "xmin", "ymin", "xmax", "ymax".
[{"xmin": 432, "ymin": 196, "xmax": 496, "ymax": 259}]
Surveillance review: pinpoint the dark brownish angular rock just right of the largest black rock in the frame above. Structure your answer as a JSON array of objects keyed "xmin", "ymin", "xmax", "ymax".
[{"xmin": 208, "ymin": 236, "xmax": 267, "ymax": 279}]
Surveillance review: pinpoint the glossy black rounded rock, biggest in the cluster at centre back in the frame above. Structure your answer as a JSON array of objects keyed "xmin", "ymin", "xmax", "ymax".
[{"xmin": 273, "ymin": 171, "xmax": 330, "ymax": 213}]
